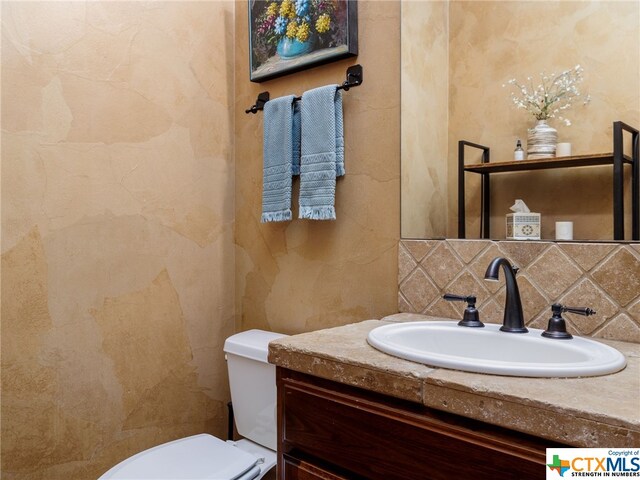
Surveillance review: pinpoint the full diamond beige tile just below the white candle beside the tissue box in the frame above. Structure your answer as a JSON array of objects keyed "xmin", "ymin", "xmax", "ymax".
[{"xmin": 527, "ymin": 245, "xmax": 581, "ymax": 298}]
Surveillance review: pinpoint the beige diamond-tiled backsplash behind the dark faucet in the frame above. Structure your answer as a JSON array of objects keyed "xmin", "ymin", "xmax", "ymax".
[{"xmin": 398, "ymin": 240, "xmax": 640, "ymax": 343}]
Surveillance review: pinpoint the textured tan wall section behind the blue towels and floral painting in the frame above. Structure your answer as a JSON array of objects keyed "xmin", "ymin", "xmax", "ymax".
[{"xmin": 235, "ymin": 1, "xmax": 400, "ymax": 333}]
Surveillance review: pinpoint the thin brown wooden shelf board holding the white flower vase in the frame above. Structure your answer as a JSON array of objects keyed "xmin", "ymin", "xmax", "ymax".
[{"xmin": 464, "ymin": 153, "xmax": 632, "ymax": 173}]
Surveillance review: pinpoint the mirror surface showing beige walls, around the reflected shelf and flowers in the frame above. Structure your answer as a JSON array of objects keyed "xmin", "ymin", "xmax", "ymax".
[{"xmin": 401, "ymin": 0, "xmax": 640, "ymax": 240}]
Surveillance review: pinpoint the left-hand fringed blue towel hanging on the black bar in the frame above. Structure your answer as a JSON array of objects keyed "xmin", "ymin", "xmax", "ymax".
[{"xmin": 261, "ymin": 95, "xmax": 300, "ymax": 223}]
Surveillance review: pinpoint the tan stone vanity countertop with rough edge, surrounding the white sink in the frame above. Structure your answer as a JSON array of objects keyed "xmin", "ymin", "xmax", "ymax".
[{"xmin": 269, "ymin": 314, "xmax": 640, "ymax": 448}]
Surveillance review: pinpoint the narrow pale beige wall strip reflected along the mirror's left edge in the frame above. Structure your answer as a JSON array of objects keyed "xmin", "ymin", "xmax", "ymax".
[{"xmin": 400, "ymin": 1, "xmax": 449, "ymax": 238}]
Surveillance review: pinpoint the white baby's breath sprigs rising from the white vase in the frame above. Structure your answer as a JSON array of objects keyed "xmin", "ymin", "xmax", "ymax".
[{"xmin": 503, "ymin": 65, "xmax": 590, "ymax": 126}]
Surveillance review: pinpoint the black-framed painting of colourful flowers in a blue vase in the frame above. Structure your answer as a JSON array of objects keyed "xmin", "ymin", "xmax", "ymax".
[{"xmin": 249, "ymin": 0, "xmax": 358, "ymax": 82}]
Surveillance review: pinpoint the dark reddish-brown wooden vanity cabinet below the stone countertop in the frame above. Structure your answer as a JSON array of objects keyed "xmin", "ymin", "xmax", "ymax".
[{"xmin": 277, "ymin": 367, "xmax": 562, "ymax": 480}]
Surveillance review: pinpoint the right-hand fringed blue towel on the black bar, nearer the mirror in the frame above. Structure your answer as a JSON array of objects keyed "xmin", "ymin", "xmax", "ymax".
[{"xmin": 299, "ymin": 85, "xmax": 344, "ymax": 220}]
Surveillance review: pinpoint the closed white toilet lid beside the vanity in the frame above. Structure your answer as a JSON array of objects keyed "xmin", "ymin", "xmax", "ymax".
[{"xmin": 99, "ymin": 434, "xmax": 259, "ymax": 480}]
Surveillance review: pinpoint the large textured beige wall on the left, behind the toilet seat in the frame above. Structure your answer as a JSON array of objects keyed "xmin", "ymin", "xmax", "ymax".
[{"xmin": 1, "ymin": 2, "xmax": 234, "ymax": 480}]
